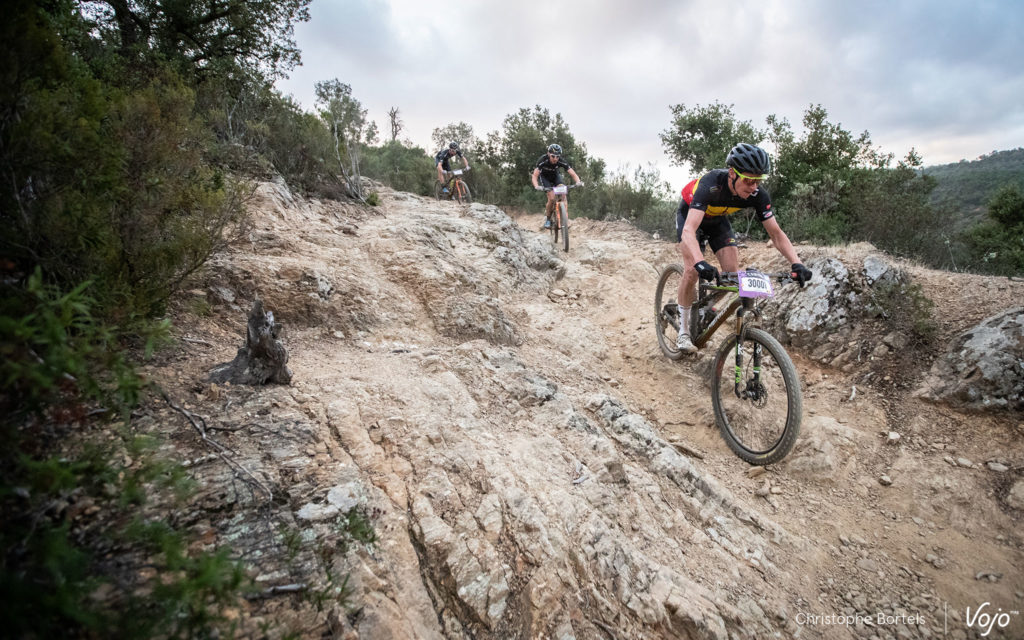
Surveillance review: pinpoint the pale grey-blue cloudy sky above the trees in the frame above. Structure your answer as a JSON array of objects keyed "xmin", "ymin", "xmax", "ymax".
[{"xmin": 278, "ymin": 0, "xmax": 1024, "ymax": 189}]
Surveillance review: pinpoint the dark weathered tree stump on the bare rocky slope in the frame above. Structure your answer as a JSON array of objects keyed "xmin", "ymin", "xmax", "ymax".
[{"xmin": 210, "ymin": 298, "xmax": 292, "ymax": 385}]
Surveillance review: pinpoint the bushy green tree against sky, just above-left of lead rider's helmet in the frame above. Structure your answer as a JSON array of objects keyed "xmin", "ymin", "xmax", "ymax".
[{"xmin": 660, "ymin": 101, "xmax": 766, "ymax": 174}]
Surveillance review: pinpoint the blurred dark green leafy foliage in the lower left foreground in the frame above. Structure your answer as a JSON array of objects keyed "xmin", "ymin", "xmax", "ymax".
[{"xmin": 0, "ymin": 270, "xmax": 251, "ymax": 638}]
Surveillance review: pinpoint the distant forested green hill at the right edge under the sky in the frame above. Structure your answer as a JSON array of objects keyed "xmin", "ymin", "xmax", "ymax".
[{"xmin": 924, "ymin": 148, "xmax": 1024, "ymax": 226}]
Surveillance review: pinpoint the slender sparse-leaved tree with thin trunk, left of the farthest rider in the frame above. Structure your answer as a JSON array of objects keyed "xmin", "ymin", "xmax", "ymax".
[{"xmin": 315, "ymin": 78, "xmax": 377, "ymax": 199}]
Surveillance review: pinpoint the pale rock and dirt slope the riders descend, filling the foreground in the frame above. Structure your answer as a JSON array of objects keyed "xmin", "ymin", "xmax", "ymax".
[{"xmin": 141, "ymin": 183, "xmax": 1024, "ymax": 640}]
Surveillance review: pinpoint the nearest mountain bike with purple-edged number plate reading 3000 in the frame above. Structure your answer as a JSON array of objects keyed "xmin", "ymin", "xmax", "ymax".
[{"xmin": 654, "ymin": 264, "xmax": 803, "ymax": 466}]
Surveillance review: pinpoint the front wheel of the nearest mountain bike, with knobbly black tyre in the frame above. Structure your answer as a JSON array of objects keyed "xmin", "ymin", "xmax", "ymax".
[{"xmin": 711, "ymin": 329, "xmax": 803, "ymax": 466}]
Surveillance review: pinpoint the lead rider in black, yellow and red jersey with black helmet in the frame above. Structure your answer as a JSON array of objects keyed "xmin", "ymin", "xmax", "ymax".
[{"xmin": 676, "ymin": 142, "xmax": 813, "ymax": 353}]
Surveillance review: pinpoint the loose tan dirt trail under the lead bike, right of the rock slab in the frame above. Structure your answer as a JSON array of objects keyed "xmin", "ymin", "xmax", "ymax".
[{"xmin": 518, "ymin": 206, "xmax": 1024, "ymax": 637}]
